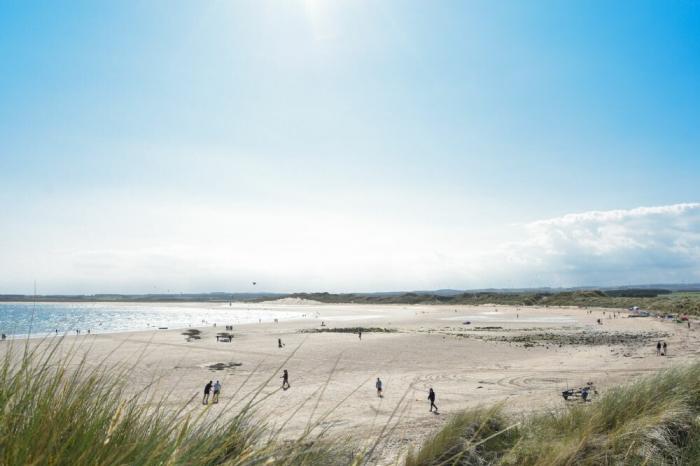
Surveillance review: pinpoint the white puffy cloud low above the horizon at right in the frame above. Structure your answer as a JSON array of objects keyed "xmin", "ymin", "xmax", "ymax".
[{"xmin": 498, "ymin": 203, "xmax": 700, "ymax": 286}]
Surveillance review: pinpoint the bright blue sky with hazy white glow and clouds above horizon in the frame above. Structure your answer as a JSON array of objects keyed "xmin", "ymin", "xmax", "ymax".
[{"xmin": 0, "ymin": 0, "xmax": 700, "ymax": 294}]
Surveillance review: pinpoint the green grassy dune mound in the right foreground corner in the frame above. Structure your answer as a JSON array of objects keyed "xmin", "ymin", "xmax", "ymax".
[{"xmin": 406, "ymin": 363, "xmax": 700, "ymax": 466}]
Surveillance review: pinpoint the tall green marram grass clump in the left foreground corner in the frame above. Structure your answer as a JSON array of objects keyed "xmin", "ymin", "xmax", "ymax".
[{"xmin": 0, "ymin": 343, "xmax": 362, "ymax": 465}]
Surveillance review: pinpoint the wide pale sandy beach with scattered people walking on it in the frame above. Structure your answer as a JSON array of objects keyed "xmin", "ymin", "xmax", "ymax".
[{"xmin": 4, "ymin": 302, "xmax": 700, "ymax": 463}]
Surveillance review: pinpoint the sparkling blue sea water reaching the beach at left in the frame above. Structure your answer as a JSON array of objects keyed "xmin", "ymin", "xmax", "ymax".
[{"xmin": 0, "ymin": 302, "xmax": 307, "ymax": 338}]
